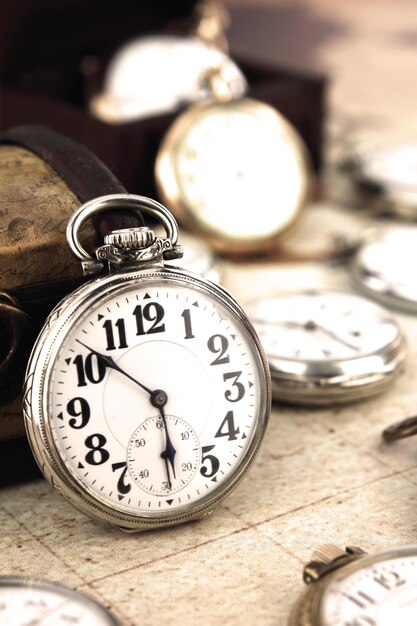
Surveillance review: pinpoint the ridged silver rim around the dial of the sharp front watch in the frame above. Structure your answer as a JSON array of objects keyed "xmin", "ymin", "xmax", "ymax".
[{"xmin": 23, "ymin": 266, "xmax": 271, "ymax": 531}]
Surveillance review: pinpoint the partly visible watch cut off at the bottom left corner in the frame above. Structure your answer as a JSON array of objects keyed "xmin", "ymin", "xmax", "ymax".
[{"xmin": 0, "ymin": 576, "xmax": 120, "ymax": 626}]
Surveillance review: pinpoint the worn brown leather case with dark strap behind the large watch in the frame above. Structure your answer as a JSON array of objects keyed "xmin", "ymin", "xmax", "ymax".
[{"xmin": 0, "ymin": 126, "xmax": 143, "ymax": 484}]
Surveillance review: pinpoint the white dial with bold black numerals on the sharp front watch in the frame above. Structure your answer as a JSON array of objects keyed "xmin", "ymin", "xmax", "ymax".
[{"xmin": 40, "ymin": 275, "xmax": 266, "ymax": 516}]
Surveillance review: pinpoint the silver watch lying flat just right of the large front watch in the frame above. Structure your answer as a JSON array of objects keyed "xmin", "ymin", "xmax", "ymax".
[{"xmin": 246, "ymin": 290, "xmax": 406, "ymax": 405}]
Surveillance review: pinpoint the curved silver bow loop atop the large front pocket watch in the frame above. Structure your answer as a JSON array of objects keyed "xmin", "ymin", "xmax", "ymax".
[{"xmin": 66, "ymin": 194, "xmax": 182, "ymax": 274}]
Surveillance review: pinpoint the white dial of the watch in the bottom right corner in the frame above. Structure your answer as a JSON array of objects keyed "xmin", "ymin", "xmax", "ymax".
[{"xmin": 320, "ymin": 555, "xmax": 417, "ymax": 626}]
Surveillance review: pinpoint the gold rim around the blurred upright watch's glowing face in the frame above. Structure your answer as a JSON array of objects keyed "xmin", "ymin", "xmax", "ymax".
[{"xmin": 155, "ymin": 97, "xmax": 313, "ymax": 254}]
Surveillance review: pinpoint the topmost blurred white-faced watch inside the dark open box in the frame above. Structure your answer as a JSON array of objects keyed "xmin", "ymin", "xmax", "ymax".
[{"xmin": 90, "ymin": 2, "xmax": 247, "ymax": 124}]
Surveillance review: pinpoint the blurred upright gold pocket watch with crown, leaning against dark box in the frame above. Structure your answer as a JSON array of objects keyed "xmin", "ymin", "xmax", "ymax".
[{"xmin": 155, "ymin": 67, "xmax": 312, "ymax": 254}]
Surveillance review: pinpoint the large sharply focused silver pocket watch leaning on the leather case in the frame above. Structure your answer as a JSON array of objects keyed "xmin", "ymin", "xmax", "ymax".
[{"xmin": 24, "ymin": 194, "xmax": 270, "ymax": 530}]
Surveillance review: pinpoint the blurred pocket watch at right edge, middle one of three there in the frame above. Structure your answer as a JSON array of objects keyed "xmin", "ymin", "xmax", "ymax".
[{"xmin": 353, "ymin": 226, "xmax": 417, "ymax": 310}]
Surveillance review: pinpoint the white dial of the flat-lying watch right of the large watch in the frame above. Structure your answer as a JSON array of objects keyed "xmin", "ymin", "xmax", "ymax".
[{"xmin": 247, "ymin": 292, "xmax": 399, "ymax": 361}]
